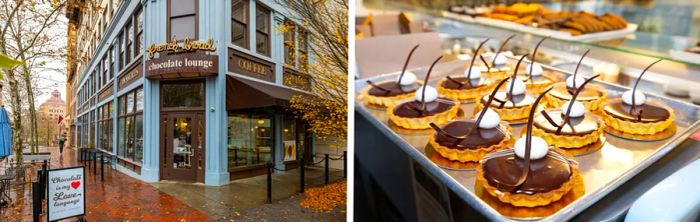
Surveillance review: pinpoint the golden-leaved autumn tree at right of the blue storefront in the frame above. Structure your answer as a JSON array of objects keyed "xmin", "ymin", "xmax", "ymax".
[{"xmin": 277, "ymin": 0, "xmax": 348, "ymax": 145}]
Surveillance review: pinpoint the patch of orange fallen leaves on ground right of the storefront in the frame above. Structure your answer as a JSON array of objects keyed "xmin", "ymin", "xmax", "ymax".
[{"xmin": 299, "ymin": 181, "xmax": 347, "ymax": 212}]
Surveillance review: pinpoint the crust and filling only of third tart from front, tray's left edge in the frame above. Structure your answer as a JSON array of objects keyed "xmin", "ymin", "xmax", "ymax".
[{"xmin": 387, "ymin": 98, "xmax": 460, "ymax": 129}]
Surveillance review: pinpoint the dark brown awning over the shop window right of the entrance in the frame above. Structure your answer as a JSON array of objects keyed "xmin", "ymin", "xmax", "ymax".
[{"xmin": 226, "ymin": 74, "xmax": 312, "ymax": 110}]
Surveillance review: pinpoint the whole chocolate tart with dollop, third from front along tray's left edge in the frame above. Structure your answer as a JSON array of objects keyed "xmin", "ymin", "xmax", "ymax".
[{"xmin": 387, "ymin": 56, "xmax": 460, "ymax": 129}]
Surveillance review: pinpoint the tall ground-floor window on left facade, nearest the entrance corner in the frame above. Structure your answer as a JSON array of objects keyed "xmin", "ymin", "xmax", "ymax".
[{"xmin": 117, "ymin": 88, "xmax": 143, "ymax": 163}]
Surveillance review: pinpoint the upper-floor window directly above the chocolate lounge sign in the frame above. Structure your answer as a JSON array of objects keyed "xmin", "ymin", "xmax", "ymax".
[{"xmin": 168, "ymin": 0, "xmax": 197, "ymax": 41}]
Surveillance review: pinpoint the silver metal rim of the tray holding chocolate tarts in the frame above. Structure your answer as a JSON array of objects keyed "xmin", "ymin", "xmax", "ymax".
[{"xmin": 354, "ymin": 56, "xmax": 700, "ymax": 221}]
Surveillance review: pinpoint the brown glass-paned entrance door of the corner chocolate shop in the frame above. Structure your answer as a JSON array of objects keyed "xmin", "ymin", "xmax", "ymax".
[{"xmin": 160, "ymin": 112, "xmax": 205, "ymax": 182}]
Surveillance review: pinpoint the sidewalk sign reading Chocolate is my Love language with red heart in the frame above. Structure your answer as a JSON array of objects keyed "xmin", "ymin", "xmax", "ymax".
[{"xmin": 46, "ymin": 166, "xmax": 85, "ymax": 221}]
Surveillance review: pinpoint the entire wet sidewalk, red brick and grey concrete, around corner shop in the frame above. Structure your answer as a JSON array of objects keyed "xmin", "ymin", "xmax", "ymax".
[{"xmin": 0, "ymin": 147, "xmax": 345, "ymax": 222}]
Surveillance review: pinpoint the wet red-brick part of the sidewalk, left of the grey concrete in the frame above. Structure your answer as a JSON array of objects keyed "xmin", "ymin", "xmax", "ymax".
[{"xmin": 0, "ymin": 147, "xmax": 211, "ymax": 221}]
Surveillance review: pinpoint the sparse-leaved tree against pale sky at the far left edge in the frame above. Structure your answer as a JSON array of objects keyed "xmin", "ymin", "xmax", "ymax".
[{"xmin": 0, "ymin": 0, "xmax": 66, "ymax": 162}]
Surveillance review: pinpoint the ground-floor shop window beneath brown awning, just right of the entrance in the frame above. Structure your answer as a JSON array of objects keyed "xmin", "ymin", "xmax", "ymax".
[{"xmin": 228, "ymin": 113, "xmax": 274, "ymax": 171}]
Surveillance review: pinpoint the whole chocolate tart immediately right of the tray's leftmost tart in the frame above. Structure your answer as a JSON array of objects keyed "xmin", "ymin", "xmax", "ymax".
[{"xmin": 438, "ymin": 39, "xmax": 495, "ymax": 102}]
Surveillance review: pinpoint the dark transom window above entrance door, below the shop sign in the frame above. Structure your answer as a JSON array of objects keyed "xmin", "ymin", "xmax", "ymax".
[{"xmin": 161, "ymin": 82, "xmax": 204, "ymax": 108}]
